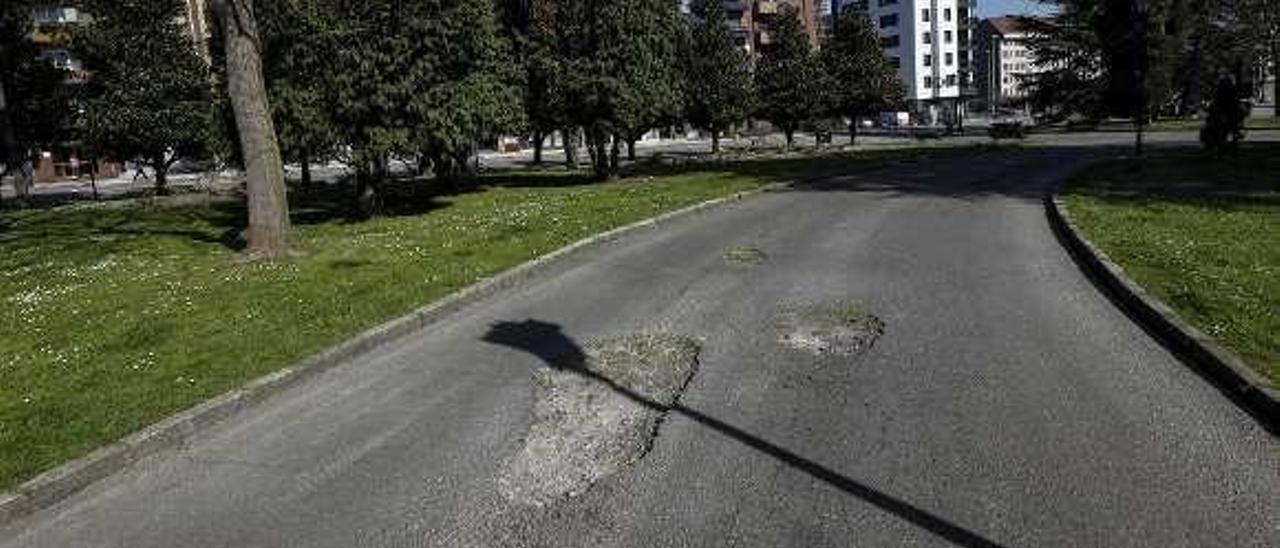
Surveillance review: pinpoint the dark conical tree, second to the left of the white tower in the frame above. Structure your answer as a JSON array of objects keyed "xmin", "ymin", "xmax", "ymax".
[{"xmin": 755, "ymin": 5, "xmax": 828, "ymax": 149}]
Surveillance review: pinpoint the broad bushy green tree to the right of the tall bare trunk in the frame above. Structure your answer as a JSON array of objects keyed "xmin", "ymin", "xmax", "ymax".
[{"xmin": 315, "ymin": 0, "xmax": 520, "ymax": 215}]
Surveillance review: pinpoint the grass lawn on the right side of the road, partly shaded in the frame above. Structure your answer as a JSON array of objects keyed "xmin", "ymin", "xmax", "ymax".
[{"xmin": 1066, "ymin": 145, "xmax": 1280, "ymax": 385}]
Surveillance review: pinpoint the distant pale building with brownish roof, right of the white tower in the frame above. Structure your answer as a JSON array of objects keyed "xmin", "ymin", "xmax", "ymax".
[{"xmin": 978, "ymin": 17, "xmax": 1043, "ymax": 109}]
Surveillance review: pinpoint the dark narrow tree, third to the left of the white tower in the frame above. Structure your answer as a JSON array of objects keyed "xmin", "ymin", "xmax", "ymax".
[{"xmin": 685, "ymin": 0, "xmax": 754, "ymax": 154}]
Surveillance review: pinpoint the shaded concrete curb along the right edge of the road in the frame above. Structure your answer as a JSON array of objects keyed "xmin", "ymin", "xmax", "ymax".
[{"xmin": 1044, "ymin": 193, "xmax": 1280, "ymax": 431}]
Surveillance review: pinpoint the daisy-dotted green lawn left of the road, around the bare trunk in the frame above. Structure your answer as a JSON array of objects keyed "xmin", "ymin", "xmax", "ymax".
[{"xmin": 0, "ymin": 144, "xmax": 967, "ymax": 489}]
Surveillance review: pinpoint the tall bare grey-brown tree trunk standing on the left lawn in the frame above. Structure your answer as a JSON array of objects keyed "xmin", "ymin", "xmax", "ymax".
[{"xmin": 212, "ymin": 0, "xmax": 289, "ymax": 259}]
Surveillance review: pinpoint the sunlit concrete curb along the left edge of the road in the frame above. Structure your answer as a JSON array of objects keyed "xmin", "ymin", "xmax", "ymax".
[{"xmin": 0, "ymin": 183, "xmax": 786, "ymax": 526}]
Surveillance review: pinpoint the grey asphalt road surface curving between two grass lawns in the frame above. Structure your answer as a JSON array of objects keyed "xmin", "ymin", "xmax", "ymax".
[{"xmin": 0, "ymin": 147, "xmax": 1280, "ymax": 548}]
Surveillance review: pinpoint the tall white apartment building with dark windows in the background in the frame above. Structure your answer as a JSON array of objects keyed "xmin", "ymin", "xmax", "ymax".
[{"xmin": 836, "ymin": 0, "xmax": 977, "ymax": 120}]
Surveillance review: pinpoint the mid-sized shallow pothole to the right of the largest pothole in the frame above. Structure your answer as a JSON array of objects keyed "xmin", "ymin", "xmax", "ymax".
[{"xmin": 778, "ymin": 301, "xmax": 884, "ymax": 356}]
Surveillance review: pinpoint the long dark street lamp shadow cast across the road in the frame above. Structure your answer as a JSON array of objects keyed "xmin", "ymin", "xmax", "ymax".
[{"xmin": 481, "ymin": 320, "xmax": 1001, "ymax": 548}]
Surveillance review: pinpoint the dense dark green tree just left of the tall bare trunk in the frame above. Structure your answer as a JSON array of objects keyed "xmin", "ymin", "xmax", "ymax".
[{"xmin": 76, "ymin": 0, "xmax": 214, "ymax": 195}]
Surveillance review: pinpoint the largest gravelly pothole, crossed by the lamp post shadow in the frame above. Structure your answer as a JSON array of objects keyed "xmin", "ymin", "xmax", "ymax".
[{"xmin": 498, "ymin": 334, "xmax": 699, "ymax": 507}]
